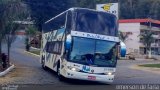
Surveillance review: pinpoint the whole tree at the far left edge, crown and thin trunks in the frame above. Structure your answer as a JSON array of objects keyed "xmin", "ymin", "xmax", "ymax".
[{"xmin": 0, "ymin": 0, "xmax": 25, "ymax": 64}]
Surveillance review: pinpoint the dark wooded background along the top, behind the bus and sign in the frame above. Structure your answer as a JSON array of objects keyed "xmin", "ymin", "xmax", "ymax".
[{"xmin": 24, "ymin": 0, "xmax": 160, "ymax": 31}]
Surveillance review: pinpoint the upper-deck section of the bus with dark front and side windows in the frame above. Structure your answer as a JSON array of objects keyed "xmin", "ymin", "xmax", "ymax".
[{"xmin": 43, "ymin": 8, "xmax": 118, "ymax": 36}]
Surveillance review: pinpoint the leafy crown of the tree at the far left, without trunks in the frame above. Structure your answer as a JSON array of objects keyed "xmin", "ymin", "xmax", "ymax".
[{"xmin": 0, "ymin": 0, "xmax": 24, "ymax": 38}]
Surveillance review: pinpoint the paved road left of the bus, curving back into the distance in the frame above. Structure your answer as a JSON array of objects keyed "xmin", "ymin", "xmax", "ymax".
[{"xmin": 0, "ymin": 38, "xmax": 102, "ymax": 85}]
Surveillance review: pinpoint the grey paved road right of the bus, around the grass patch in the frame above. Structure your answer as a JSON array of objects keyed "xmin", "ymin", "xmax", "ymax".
[{"xmin": 114, "ymin": 60, "xmax": 160, "ymax": 84}]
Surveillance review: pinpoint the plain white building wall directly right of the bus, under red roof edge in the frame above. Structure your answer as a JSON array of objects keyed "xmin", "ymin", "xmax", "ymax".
[{"xmin": 119, "ymin": 23, "xmax": 140, "ymax": 53}]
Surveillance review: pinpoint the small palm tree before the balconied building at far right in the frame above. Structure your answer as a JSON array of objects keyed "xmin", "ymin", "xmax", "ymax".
[{"xmin": 140, "ymin": 31, "xmax": 154, "ymax": 58}]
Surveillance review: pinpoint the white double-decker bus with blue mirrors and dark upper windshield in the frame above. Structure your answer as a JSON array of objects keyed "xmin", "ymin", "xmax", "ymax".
[{"xmin": 40, "ymin": 8, "xmax": 125, "ymax": 83}]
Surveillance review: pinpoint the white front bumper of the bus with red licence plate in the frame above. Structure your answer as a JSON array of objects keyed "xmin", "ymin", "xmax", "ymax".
[{"xmin": 64, "ymin": 70, "xmax": 114, "ymax": 83}]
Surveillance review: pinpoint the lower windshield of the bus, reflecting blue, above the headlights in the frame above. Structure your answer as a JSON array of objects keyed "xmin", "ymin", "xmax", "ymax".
[{"xmin": 69, "ymin": 37, "xmax": 117, "ymax": 67}]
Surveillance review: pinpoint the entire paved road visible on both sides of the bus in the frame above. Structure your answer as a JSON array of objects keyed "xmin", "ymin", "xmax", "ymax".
[{"xmin": 0, "ymin": 35, "xmax": 160, "ymax": 85}]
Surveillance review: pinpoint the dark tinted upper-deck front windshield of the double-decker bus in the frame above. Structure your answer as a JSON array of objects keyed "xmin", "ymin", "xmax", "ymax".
[{"xmin": 75, "ymin": 11, "xmax": 117, "ymax": 36}]
